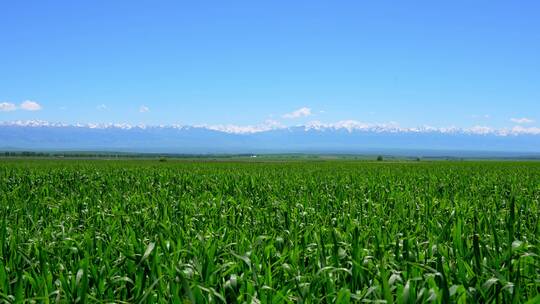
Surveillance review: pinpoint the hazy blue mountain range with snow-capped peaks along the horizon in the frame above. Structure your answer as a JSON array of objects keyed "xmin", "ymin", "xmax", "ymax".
[{"xmin": 0, "ymin": 120, "xmax": 540, "ymax": 153}]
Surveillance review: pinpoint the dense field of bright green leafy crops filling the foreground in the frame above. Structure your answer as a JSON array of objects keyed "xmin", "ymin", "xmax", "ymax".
[{"xmin": 0, "ymin": 161, "xmax": 540, "ymax": 303}]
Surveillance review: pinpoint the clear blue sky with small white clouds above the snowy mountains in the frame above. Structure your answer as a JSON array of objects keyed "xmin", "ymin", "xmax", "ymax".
[{"xmin": 0, "ymin": 0, "xmax": 540, "ymax": 128}]
